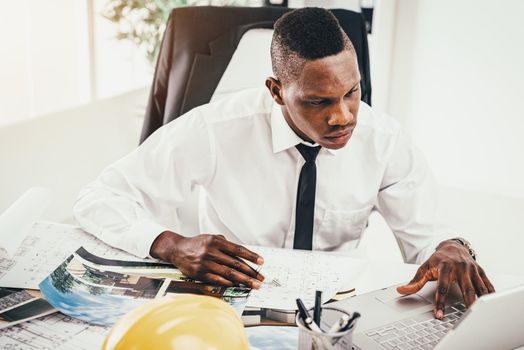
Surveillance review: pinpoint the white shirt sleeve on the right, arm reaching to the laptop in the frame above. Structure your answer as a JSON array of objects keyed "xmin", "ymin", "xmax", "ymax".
[{"xmin": 377, "ymin": 131, "xmax": 456, "ymax": 264}]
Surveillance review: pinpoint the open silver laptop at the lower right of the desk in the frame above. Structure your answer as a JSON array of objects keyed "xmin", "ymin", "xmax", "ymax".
[{"xmin": 326, "ymin": 282, "xmax": 524, "ymax": 350}]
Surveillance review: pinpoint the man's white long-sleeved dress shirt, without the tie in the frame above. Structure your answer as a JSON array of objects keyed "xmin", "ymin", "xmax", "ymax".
[{"xmin": 74, "ymin": 89, "xmax": 453, "ymax": 263}]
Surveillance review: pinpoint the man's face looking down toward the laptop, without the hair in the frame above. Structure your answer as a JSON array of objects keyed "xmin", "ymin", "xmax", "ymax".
[{"xmin": 272, "ymin": 50, "xmax": 361, "ymax": 149}]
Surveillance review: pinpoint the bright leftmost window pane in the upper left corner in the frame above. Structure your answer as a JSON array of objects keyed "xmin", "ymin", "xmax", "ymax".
[{"xmin": 0, "ymin": 0, "xmax": 89, "ymax": 125}]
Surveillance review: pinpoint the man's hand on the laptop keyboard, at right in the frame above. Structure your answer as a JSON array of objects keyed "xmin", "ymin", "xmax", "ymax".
[{"xmin": 397, "ymin": 240, "xmax": 495, "ymax": 320}]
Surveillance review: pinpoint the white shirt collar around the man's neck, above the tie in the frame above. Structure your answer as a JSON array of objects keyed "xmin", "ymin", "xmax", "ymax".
[{"xmin": 271, "ymin": 102, "xmax": 339, "ymax": 155}]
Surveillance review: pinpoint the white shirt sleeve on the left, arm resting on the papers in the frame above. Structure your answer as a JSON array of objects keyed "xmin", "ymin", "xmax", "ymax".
[{"xmin": 73, "ymin": 112, "xmax": 214, "ymax": 257}]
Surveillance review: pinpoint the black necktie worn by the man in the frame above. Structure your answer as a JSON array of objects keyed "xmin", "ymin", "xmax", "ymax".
[{"xmin": 293, "ymin": 144, "xmax": 320, "ymax": 250}]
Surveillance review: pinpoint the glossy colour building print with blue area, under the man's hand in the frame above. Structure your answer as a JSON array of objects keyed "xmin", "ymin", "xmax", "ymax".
[{"xmin": 39, "ymin": 248, "xmax": 249, "ymax": 325}]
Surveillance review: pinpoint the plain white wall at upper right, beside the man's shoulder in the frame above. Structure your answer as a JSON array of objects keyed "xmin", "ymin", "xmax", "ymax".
[{"xmin": 388, "ymin": 0, "xmax": 524, "ymax": 199}]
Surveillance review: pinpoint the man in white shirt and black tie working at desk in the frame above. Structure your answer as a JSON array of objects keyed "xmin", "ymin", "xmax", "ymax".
[{"xmin": 75, "ymin": 8, "xmax": 494, "ymax": 318}]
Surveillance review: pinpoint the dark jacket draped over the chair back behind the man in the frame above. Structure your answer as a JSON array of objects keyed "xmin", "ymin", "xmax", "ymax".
[{"xmin": 140, "ymin": 6, "xmax": 371, "ymax": 142}]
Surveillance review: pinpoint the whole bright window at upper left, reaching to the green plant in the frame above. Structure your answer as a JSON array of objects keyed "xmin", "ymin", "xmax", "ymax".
[{"xmin": 0, "ymin": 0, "xmax": 153, "ymax": 126}]
